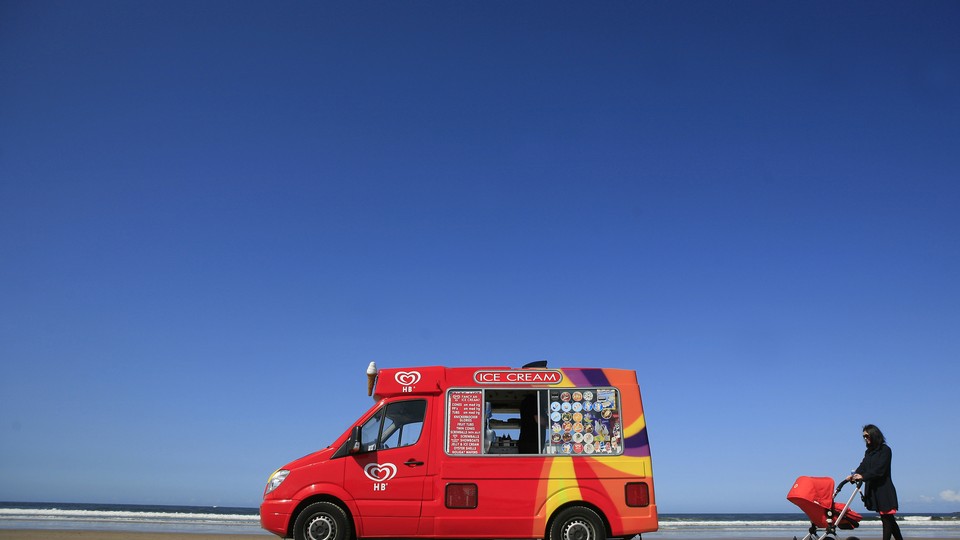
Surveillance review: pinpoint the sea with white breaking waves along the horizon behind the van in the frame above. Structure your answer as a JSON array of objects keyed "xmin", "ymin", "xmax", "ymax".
[{"xmin": 0, "ymin": 502, "xmax": 960, "ymax": 540}]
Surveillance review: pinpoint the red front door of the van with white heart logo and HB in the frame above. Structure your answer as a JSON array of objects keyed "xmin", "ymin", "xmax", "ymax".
[{"xmin": 344, "ymin": 398, "xmax": 430, "ymax": 537}]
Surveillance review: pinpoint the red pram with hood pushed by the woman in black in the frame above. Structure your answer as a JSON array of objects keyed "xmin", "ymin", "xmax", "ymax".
[{"xmin": 787, "ymin": 476, "xmax": 863, "ymax": 540}]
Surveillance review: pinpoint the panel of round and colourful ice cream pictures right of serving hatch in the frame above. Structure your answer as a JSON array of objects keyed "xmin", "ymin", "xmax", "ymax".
[{"xmin": 547, "ymin": 388, "xmax": 623, "ymax": 455}]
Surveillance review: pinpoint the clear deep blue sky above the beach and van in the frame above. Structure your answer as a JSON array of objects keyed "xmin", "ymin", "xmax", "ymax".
[{"xmin": 0, "ymin": 0, "xmax": 960, "ymax": 513}]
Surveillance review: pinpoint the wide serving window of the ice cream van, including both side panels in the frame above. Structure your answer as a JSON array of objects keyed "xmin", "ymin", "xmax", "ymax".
[{"xmin": 446, "ymin": 387, "xmax": 623, "ymax": 456}]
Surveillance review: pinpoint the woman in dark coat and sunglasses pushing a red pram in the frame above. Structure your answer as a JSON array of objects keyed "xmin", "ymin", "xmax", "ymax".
[{"xmin": 847, "ymin": 424, "xmax": 903, "ymax": 540}]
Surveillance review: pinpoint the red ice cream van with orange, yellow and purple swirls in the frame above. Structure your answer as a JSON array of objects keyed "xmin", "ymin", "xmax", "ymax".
[{"xmin": 260, "ymin": 363, "xmax": 658, "ymax": 540}]
